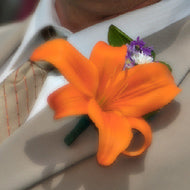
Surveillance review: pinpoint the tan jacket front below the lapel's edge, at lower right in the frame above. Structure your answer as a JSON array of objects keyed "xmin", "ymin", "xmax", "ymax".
[{"xmin": 30, "ymin": 74, "xmax": 190, "ymax": 190}]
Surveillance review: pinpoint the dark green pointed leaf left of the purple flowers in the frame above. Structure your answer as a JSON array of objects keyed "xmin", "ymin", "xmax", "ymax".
[{"xmin": 108, "ymin": 25, "xmax": 133, "ymax": 47}]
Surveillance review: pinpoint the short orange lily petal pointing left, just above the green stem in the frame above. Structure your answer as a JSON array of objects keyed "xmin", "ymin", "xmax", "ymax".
[{"xmin": 48, "ymin": 84, "xmax": 88, "ymax": 119}]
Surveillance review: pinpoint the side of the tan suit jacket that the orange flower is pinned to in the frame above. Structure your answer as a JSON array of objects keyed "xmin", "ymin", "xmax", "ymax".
[{"xmin": 0, "ymin": 17, "xmax": 190, "ymax": 190}]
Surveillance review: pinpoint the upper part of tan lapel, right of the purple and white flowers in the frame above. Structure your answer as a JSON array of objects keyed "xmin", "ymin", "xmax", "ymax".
[{"xmin": 145, "ymin": 16, "xmax": 190, "ymax": 84}]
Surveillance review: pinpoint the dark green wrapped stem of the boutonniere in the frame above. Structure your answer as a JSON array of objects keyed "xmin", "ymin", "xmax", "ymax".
[{"xmin": 64, "ymin": 115, "xmax": 92, "ymax": 146}]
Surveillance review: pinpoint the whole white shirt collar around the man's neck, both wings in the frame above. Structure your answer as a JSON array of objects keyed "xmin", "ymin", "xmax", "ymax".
[{"xmin": 20, "ymin": 0, "xmax": 190, "ymax": 57}]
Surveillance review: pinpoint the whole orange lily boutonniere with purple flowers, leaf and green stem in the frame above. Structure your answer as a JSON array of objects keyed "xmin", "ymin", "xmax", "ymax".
[{"xmin": 31, "ymin": 25, "xmax": 181, "ymax": 165}]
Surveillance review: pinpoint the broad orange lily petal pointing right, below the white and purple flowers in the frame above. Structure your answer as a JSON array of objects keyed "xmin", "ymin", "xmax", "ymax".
[{"xmin": 107, "ymin": 63, "xmax": 181, "ymax": 117}]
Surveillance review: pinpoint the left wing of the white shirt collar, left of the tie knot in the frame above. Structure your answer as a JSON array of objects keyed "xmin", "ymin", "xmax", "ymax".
[{"xmin": 3, "ymin": 0, "xmax": 72, "ymax": 81}]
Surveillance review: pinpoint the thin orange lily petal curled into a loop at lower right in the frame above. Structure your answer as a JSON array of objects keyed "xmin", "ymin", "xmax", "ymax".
[{"xmin": 123, "ymin": 118, "xmax": 152, "ymax": 156}]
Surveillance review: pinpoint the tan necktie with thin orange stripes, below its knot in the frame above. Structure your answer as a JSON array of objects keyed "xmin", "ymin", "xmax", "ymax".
[{"xmin": 0, "ymin": 61, "xmax": 50, "ymax": 143}]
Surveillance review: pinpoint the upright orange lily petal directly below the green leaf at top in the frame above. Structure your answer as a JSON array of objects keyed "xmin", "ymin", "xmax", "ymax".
[{"xmin": 90, "ymin": 42, "xmax": 127, "ymax": 93}]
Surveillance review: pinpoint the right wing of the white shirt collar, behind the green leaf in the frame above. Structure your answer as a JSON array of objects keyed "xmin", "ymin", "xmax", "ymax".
[{"xmin": 68, "ymin": 0, "xmax": 190, "ymax": 57}]
